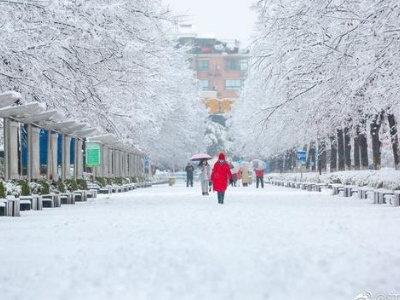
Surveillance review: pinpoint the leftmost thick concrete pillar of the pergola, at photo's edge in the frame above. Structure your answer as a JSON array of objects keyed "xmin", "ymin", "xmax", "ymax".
[{"xmin": 4, "ymin": 118, "xmax": 19, "ymax": 180}]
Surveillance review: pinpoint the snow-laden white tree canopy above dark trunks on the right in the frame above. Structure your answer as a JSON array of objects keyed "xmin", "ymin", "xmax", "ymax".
[{"xmin": 231, "ymin": 0, "xmax": 400, "ymax": 167}]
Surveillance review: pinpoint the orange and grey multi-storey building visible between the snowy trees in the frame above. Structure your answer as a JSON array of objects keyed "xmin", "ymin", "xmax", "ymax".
[{"xmin": 179, "ymin": 38, "xmax": 249, "ymax": 114}]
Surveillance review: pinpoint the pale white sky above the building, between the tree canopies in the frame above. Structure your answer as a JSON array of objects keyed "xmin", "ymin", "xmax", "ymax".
[{"xmin": 163, "ymin": 0, "xmax": 256, "ymax": 46}]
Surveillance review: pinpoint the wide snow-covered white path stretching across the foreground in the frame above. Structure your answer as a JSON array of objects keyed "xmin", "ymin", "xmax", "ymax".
[{"xmin": 0, "ymin": 184, "xmax": 400, "ymax": 300}]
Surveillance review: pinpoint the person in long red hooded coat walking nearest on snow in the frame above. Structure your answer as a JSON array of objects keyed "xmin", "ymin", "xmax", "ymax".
[{"xmin": 211, "ymin": 153, "xmax": 233, "ymax": 204}]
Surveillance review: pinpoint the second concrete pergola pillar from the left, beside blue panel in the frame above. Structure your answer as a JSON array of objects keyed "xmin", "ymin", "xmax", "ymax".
[{"xmin": 27, "ymin": 124, "xmax": 40, "ymax": 181}]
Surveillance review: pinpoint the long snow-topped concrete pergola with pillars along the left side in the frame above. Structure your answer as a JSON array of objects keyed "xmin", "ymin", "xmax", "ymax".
[{"xmin": 0, "ymin": 92, "xmax": 145, "ymax": 181}]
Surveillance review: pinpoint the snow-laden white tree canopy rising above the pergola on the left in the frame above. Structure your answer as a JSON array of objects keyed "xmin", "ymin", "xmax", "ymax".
[{"xmin": 0, "ymin": 0, "xmax": 204, "ymax": 166}]
